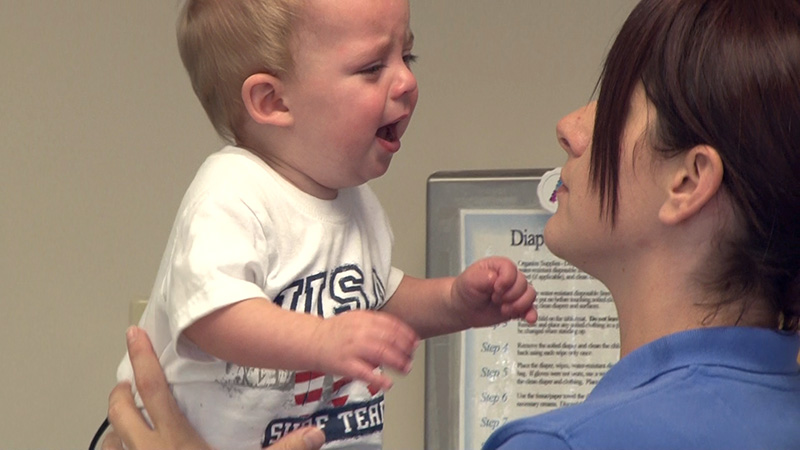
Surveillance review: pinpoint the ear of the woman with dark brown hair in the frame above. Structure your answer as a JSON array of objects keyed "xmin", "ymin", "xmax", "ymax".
[{"xmin": 658, "ymin": 145, "xmax": 724, "ymax": 225}]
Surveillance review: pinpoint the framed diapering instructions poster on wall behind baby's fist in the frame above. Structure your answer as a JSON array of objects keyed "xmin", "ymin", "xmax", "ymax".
[{"xmin": 425, "ymin": 169, "xmax": 619, "ymax": 450}]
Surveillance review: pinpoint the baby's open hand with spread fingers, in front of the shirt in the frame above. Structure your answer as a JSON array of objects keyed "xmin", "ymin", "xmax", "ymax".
[{"xmin": 314, "ymin": 310, "xmax": 419, "ymax": 390}]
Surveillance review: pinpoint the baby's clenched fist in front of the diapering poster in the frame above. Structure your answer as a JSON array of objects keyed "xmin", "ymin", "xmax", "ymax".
[{"xmin": 451, "ymin": 257, "xmax": 538, "ymax": 327}]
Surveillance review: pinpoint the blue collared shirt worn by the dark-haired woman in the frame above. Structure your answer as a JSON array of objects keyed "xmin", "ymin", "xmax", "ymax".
[{"xmin": 484, "ymin": 327, "xmax": 800, "ymax": 450}]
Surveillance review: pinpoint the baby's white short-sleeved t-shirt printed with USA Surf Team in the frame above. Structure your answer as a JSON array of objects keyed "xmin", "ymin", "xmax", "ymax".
[{"xmin": 117, "ymin": 146, "xmax": 403, "ymax": 449}]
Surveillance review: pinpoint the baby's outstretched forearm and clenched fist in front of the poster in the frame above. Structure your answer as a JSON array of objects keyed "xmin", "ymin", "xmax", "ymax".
[{"xmin": 382, "ymin": 257, "xmax": 537, "ymax": 339}]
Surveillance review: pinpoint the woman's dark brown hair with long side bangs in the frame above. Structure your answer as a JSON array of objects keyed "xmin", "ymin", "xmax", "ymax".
[{"xmin": 591, "ymin": 0, "xmax": 800, "ymax": 331}]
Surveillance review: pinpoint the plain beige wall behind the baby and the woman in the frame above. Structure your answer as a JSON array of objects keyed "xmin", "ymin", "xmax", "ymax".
[{"xmin": 0, "ymin": 0, "xmax": 634, "ymax": 449}]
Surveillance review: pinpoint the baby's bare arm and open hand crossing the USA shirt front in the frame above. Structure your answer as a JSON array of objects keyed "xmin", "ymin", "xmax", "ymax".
[{"xmin": 184, "ymin": 298, "xmax": 419, "ymax": 390}]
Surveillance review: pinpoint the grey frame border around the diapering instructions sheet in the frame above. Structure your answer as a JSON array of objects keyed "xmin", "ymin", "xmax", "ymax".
[{"xmin": 425, "ymin": 168, "xmax": 552, "ymax": 450}]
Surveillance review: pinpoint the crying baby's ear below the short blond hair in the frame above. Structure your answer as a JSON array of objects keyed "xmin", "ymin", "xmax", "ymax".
[{"xmin": 242, "ymin": 73, "xmax": 292, "ymax": 127}]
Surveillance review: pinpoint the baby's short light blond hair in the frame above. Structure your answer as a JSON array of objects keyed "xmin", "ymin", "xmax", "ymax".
[{"xmin": 177, "ymin": 0, "xmax": 301, "ymax": 143}]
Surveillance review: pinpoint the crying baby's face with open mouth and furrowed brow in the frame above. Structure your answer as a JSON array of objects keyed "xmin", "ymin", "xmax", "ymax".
[{"xmin": 276, "ymin": 0, "xmax": 418, "ymax": 198}]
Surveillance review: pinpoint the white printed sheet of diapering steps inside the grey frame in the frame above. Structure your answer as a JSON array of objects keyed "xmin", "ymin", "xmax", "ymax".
[{"xmin": 459, "ymin": 209, "xmax": 619, "ymax": 449}]
